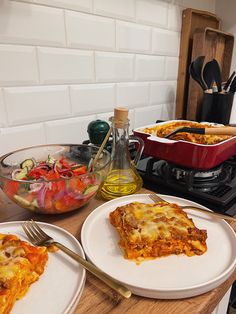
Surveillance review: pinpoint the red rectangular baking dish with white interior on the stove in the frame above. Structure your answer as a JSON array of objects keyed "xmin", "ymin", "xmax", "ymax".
[{"xmin": 133, "ymin": 120, "xmax": 236, "ymax": 170}]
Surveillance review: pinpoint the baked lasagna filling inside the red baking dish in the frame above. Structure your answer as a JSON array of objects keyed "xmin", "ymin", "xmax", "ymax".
[{"xmin": 141, "ymin": 121, "xmax": 232, "ymax": 145}]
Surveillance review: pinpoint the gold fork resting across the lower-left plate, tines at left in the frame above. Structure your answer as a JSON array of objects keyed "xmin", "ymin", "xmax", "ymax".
[{"xmin": 22, "ymin": 220, "xmax": 131, "ymax": 299}]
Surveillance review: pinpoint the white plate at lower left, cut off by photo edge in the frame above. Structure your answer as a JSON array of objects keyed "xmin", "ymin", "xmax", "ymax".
[{"xmin": 0, "ymin": 221, "xmax": 85, "ymax": 314}]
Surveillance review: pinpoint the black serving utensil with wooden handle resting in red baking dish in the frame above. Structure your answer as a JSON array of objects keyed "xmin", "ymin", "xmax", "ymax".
[{"xmin": 165, "ymin": 127, "xmax": 236, "ymax": 138}]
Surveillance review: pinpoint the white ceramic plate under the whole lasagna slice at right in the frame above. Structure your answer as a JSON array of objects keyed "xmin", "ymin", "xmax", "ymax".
[{"xmin": 82, "ymin": 194, "xmax": 236, "ymax": 299}]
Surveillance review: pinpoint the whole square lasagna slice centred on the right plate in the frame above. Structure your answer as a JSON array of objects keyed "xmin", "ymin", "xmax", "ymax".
[{"xmin": 109, "ymin": 202, "xmax": 207, "ymax": 261}]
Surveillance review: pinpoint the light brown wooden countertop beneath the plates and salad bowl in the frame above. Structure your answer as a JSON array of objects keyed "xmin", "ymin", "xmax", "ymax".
[{"xmin": 0, "ymin": 189, "xmax": 236, "ymax": 314}]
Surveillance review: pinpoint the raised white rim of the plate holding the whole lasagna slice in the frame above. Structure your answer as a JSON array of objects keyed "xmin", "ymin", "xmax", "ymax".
[{"xmin": 81, "ymin": 193, "xmax": 236, "ymax": 299}]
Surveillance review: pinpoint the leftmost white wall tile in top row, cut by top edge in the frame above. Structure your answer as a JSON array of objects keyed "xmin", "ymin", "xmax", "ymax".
[{"xmin": 32, "ymin": 0, "xmax": 93, "ymax": 12}]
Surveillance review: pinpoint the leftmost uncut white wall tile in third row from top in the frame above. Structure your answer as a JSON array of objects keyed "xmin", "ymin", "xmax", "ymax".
[{"xmin": 38, "ymin": 47, "xmax": 94, "ymax": 84}]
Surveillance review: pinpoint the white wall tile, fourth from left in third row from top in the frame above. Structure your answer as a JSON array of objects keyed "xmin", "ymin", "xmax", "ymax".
[{"xmin": 135, "ymin": 55, "xmax": 165, "ymax": 81}]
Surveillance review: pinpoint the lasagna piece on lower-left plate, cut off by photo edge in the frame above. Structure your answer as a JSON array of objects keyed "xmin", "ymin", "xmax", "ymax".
[{"xmin": 0, "ymin": 234, "xmax": 48, "ymax": 314}]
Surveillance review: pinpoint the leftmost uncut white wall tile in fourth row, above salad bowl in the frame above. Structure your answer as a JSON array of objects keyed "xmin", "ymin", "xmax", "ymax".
[{"xmin": 4, "ymin": 85, "xmax": 70, "ymax": 125}]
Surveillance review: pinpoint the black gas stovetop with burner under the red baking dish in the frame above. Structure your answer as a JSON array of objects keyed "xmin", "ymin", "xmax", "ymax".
[{"xmin": 137, "ymin": 156, "xmax": 236, "ymax": 216}]
